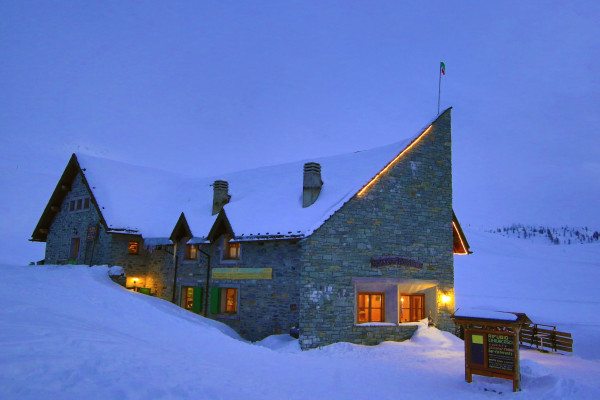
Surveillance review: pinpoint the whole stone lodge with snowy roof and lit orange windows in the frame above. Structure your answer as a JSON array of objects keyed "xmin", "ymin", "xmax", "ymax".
[{"xmin": 31, "ymin": 109, "xmax": 469, "ymax": 349}]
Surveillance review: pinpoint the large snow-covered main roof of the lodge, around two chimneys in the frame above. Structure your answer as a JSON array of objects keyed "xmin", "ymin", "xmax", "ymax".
[{"xmin": 76, "ymin": 116, "xmax": 440, "ymax": 240}]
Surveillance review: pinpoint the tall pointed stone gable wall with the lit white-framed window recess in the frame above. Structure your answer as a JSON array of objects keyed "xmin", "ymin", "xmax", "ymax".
[{"xmin": 300, "ymin": 110, "xmax": 454, "ymax": 349}]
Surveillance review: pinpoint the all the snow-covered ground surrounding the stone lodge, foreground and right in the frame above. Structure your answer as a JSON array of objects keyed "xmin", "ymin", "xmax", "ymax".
[{"xmin": 0, "ymin": 230, "xmax": 600, "ymax": 400}]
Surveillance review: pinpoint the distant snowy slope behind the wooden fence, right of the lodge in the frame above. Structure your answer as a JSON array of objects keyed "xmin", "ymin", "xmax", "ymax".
[{"xmin": 455, "ymin": 228, "xmax": 600, "ymax": 359}]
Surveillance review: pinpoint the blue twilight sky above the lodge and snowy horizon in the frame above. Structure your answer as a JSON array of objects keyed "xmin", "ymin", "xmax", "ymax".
[{"xmin": 0, "ymin": 0, "xmax": 600, "ymax": 264}]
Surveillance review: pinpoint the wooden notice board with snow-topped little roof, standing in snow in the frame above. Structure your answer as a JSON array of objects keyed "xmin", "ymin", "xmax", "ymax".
[{"xmin": 453, "ymin": 311, "xmax": 531, "ymax": 392}]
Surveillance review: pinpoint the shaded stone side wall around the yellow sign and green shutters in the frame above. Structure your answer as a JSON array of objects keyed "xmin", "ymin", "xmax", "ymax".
[{"xmin": 177, "ymin": 237, "xmax": 300, "ymax": 341}]
